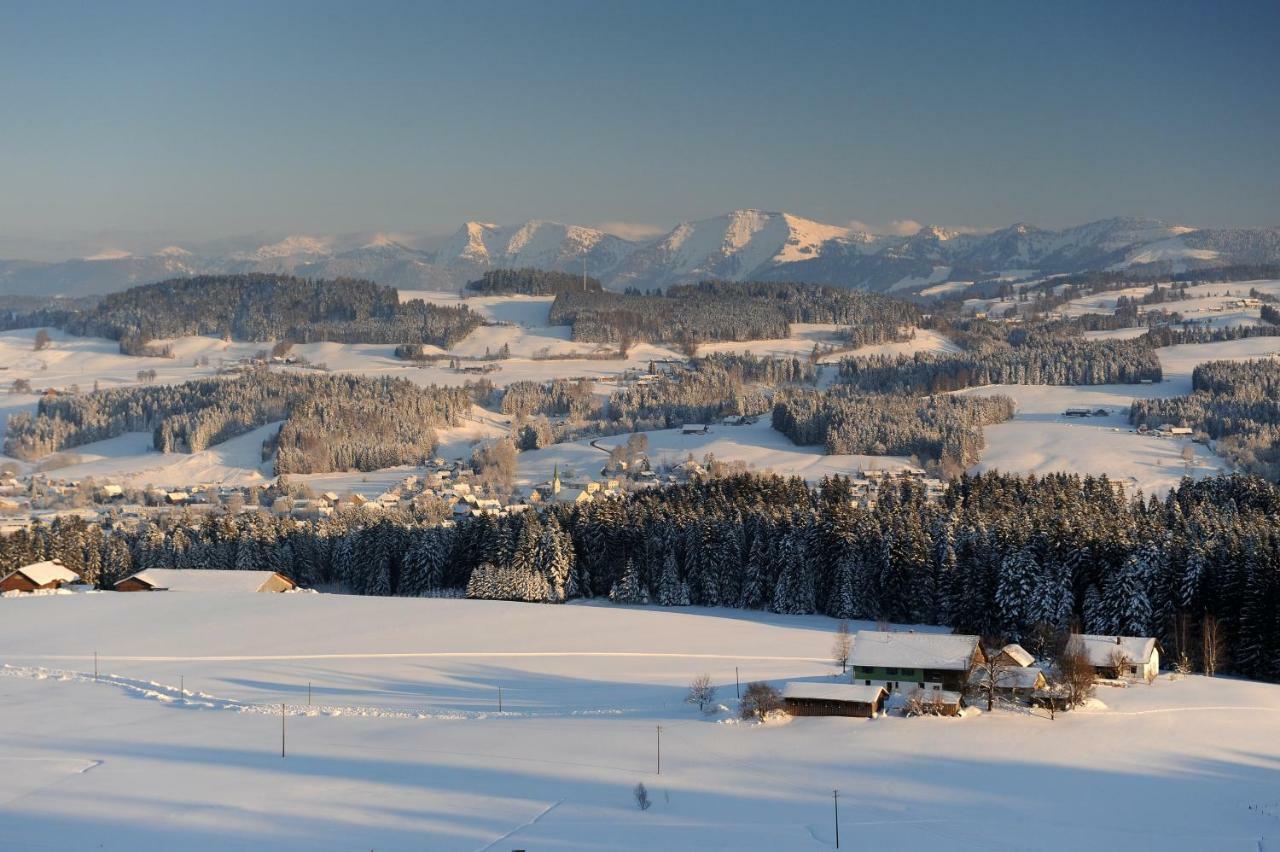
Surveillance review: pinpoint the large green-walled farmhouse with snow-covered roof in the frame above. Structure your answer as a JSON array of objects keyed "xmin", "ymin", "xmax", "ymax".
[{"xmin": 849, "ymin": 631, "xmax": 987, "ymax": 692}]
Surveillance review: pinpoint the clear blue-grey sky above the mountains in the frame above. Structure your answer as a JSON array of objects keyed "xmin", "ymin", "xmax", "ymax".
[{"xmin": 0, "ymin": 0, "xmax": 1280, "ymax": 257}]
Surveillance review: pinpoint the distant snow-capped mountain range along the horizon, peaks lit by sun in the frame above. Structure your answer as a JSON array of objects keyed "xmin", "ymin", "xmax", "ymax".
[{"xmin": 0, "ymin": 210, "xmax": 1280, "ymax": 296}]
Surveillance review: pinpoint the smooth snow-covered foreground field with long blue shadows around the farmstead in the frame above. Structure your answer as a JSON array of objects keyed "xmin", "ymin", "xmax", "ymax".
[{"xmin": 0, "ymin": 592, "xmax": 1280, "ymax": 852}]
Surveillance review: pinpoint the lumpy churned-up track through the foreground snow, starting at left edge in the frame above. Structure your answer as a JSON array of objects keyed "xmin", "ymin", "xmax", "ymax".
[{"xmin": 0, "ymin": 658, "xmax": 636, "ymax": 722}]
